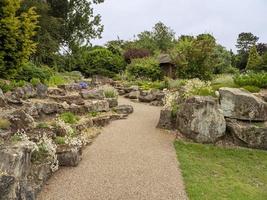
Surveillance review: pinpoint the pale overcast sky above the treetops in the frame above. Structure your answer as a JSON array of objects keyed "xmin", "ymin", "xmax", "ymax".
[{"xmin": 93, "ymin": 0, "xmax": 267, "ymax": 50}]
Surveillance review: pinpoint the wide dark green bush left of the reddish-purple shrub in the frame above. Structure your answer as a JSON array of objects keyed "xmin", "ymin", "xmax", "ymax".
[{"xmin": 78, "ymin": 48, "xmax": 126, "ymax": 77}]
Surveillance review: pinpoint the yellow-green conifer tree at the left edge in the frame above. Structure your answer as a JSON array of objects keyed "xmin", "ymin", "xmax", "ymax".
[{"xmin": 0, "ymin": 0, "xmax": 38, "ymax": 78}]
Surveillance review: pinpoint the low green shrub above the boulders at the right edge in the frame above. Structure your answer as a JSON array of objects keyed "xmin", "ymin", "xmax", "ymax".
[{"xmin": 234, "ymin": 72, "xmax": 267, "ymax": 88}]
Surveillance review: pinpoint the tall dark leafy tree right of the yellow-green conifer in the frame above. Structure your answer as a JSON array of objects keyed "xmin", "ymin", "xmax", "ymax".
[{"xmin": 22, "ymin": 0, "xmax": 104, "ymax": 65}]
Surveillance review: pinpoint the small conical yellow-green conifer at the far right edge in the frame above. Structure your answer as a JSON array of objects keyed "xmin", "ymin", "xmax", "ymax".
[{"xmin": 246, "ymin": 46, "xmax": 263, "ymax": 71}]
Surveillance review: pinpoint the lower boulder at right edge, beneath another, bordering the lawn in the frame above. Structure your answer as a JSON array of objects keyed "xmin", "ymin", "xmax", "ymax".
[{"xmin": 226, "ymin": 119, "xmax": 267, "ymax": 150}]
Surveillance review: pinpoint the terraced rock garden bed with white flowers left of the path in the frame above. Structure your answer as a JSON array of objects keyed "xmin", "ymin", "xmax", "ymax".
[{"xmin": 0, "ymin": 82, "xmax": 133, "ymax": 200}]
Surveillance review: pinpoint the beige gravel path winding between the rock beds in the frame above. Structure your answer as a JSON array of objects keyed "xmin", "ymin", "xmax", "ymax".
[{"xmin": 38, "ymin": 99, "xmax": 186, "ymax": 200}]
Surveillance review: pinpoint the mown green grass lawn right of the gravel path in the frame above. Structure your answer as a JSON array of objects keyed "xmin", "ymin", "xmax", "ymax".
[{"xmin": 175, "ymin": 141, "xmax": 267, "ymax": 200}]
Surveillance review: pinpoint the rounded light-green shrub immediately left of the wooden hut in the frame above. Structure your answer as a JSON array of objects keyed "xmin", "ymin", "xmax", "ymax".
[{"xmin": 126, "ymin": 58, "xmax": 163, "ymax": 81}]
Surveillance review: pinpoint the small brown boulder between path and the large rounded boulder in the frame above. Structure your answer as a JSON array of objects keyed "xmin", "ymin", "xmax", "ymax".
[{"xmin": 157, "ymin": 109, "xmax": 175, "ymax": 130}]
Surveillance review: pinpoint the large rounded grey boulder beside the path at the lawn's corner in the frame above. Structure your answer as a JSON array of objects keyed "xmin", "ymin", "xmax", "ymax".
[{"xmin": 176, "ymin": 96, "xmax": 226, "ymax": 143}]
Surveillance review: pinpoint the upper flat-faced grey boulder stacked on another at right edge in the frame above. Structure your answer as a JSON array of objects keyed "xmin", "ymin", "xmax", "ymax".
[{"xmin": 219, "ymin": 88, "xmax": 267, "ymax": 121}]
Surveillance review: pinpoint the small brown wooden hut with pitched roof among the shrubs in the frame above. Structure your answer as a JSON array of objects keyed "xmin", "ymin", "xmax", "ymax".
[{"xmin": 158, "ymin": 54, "xmax": 176, "ymax": 79}]
